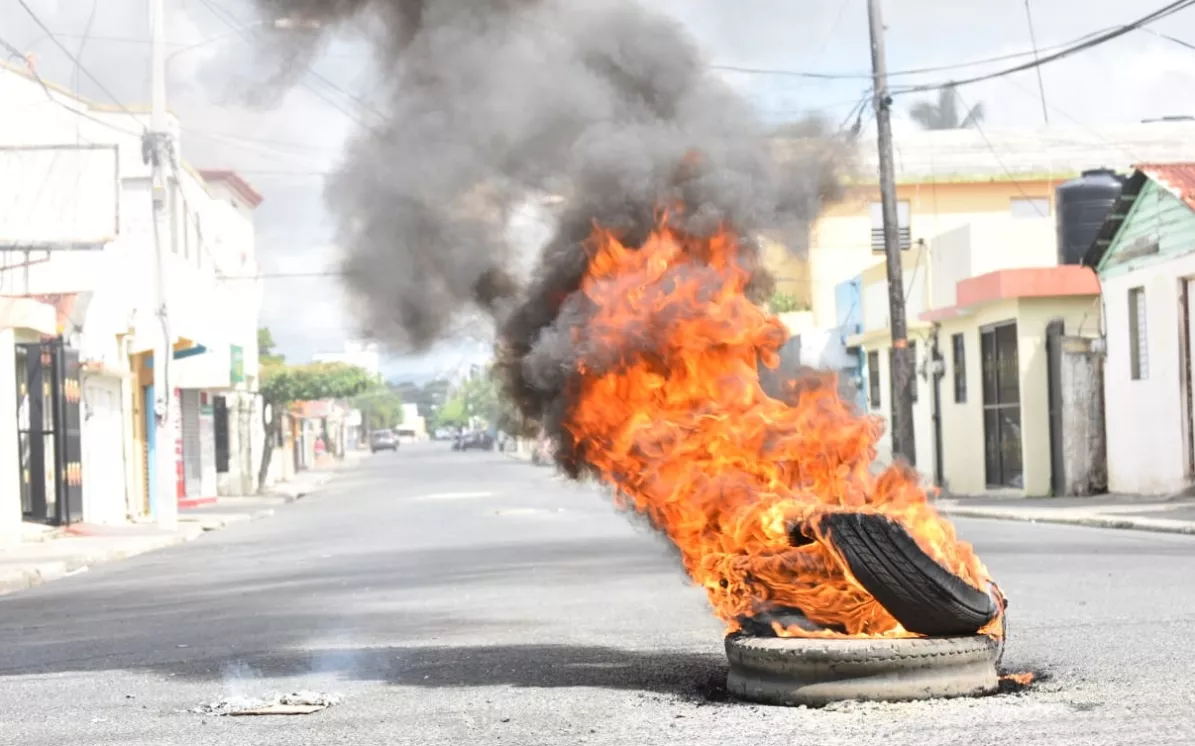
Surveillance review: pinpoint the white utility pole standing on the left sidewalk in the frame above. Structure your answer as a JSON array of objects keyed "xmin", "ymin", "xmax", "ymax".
[{"xmin": 141, "ymin": 0, "xmax": 178, "ymax": 530}]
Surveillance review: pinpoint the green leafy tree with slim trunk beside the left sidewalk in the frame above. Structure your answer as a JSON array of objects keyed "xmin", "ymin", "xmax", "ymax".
[{"xmin": 257, "ymin": 362, "xmax": 379, "ymax": 490}]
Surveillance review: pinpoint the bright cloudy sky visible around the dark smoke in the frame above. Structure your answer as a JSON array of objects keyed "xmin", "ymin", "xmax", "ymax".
[{"xmin": 0, "ymin": 0, "xmax": 1195, "ymax": 380}]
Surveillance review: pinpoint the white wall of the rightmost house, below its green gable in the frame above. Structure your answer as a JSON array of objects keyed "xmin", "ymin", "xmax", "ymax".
[{"xmin": 1101, "ymin": 255, "xmax": 1195, "ymax": 494}]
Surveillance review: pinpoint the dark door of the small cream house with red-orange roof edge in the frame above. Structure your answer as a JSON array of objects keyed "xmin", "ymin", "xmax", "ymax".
[{"xmin": 980, "ymin": 322, "xmax": 1024, "ymax": 489}]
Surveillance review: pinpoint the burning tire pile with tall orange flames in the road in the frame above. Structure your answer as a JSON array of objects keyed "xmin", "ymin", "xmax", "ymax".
[{"xmin": 497, "ymin": 213, "xmax": 1027, "ymax": 704}]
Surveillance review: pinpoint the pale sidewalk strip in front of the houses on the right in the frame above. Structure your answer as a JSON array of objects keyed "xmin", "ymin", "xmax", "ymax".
[{"xmin": 934, "ymin": 495, "xmax": 1195, "ymax": 534}]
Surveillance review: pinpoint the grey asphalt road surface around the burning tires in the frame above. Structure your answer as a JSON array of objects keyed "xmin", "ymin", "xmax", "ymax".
[{"xmin": 0, "ymin": 444, "xmax": 1195, "ymax": 746}]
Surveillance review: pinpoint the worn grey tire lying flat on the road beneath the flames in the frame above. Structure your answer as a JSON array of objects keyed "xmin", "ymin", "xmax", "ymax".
[{"xmin": 725, "ymin": 634, "xmax": 1003, "ymax": 707}]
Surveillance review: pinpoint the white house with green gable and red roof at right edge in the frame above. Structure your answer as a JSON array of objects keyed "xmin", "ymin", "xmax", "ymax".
[{"xmin": 1086, "ymin": 163, "xmax": 1195, "ymax": 494}]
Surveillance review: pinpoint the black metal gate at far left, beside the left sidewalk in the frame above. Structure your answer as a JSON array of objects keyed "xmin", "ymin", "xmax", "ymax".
[{"xmin": 16, "ymin": 337, "xmax": 82, "ymax": 525}]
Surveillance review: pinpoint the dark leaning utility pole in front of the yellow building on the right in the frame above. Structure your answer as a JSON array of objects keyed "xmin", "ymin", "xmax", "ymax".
[{"xmin": 868, "ymin": 0, "xmax": 915, "ymax": 464}]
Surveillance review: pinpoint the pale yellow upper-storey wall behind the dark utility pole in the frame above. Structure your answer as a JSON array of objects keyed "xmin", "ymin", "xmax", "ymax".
[{"xmin": 809, "ymin": 179, "xmax": 1062, "ymax": 326}]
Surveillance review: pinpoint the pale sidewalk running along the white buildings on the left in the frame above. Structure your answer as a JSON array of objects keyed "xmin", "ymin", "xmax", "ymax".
[{"xmin": 0, "ymin": 458, "xmax": 361, "ymax": 595}]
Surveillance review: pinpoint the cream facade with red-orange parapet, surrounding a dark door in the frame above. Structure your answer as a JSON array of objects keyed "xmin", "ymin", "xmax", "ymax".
[{"xmin": 931, "ymin": 296, "xmax": 1099, "ymax": 496}]
